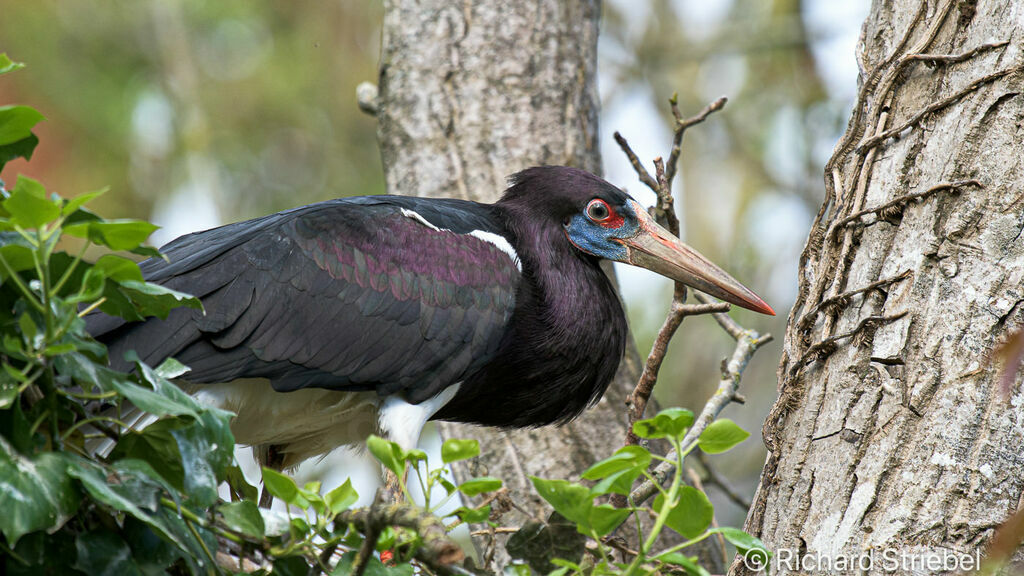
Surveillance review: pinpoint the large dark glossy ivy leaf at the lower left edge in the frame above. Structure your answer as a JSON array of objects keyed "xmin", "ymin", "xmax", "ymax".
[{"xmin": 0, "ymin": 436, "xmax": 80, "ymax": 546}]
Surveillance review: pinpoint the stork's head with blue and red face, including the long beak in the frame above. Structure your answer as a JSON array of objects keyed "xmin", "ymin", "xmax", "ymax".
[{"xmin": 503, "ymin": 166, "xmax": 775, "ymax": 316}]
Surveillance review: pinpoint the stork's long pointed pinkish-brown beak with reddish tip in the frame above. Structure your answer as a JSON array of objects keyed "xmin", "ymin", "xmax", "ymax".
[{"xmin": 618, "ymin": 201, "xmax": 775, "ymax": 316}]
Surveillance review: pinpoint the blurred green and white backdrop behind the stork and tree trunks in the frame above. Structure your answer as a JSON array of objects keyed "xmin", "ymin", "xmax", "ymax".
[{"xmin": 0, "ymin": 0, "xmax": 868, "ymax": 526}]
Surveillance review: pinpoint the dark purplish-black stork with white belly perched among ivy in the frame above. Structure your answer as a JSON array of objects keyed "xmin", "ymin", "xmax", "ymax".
[{"xmin": 88, "ymin": 166, "xmax": 774, "ymax": 466}]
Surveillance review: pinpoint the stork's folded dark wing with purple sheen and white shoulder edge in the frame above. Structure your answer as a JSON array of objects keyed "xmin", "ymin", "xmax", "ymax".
[{"xmin": 88, "ymin": 197, "xmax": 520, "ymax": 402}]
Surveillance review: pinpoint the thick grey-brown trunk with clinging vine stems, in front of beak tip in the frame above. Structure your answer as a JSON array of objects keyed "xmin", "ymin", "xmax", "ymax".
[{"xmin": 733, "ymin": 0, "xmax": 1024, "ymax": 574}]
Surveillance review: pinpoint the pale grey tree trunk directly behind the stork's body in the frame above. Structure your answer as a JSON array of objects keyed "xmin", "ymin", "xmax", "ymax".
[{"xmin": 378, "ymin": 0, "xmax": 639, "ymax": 562}]
